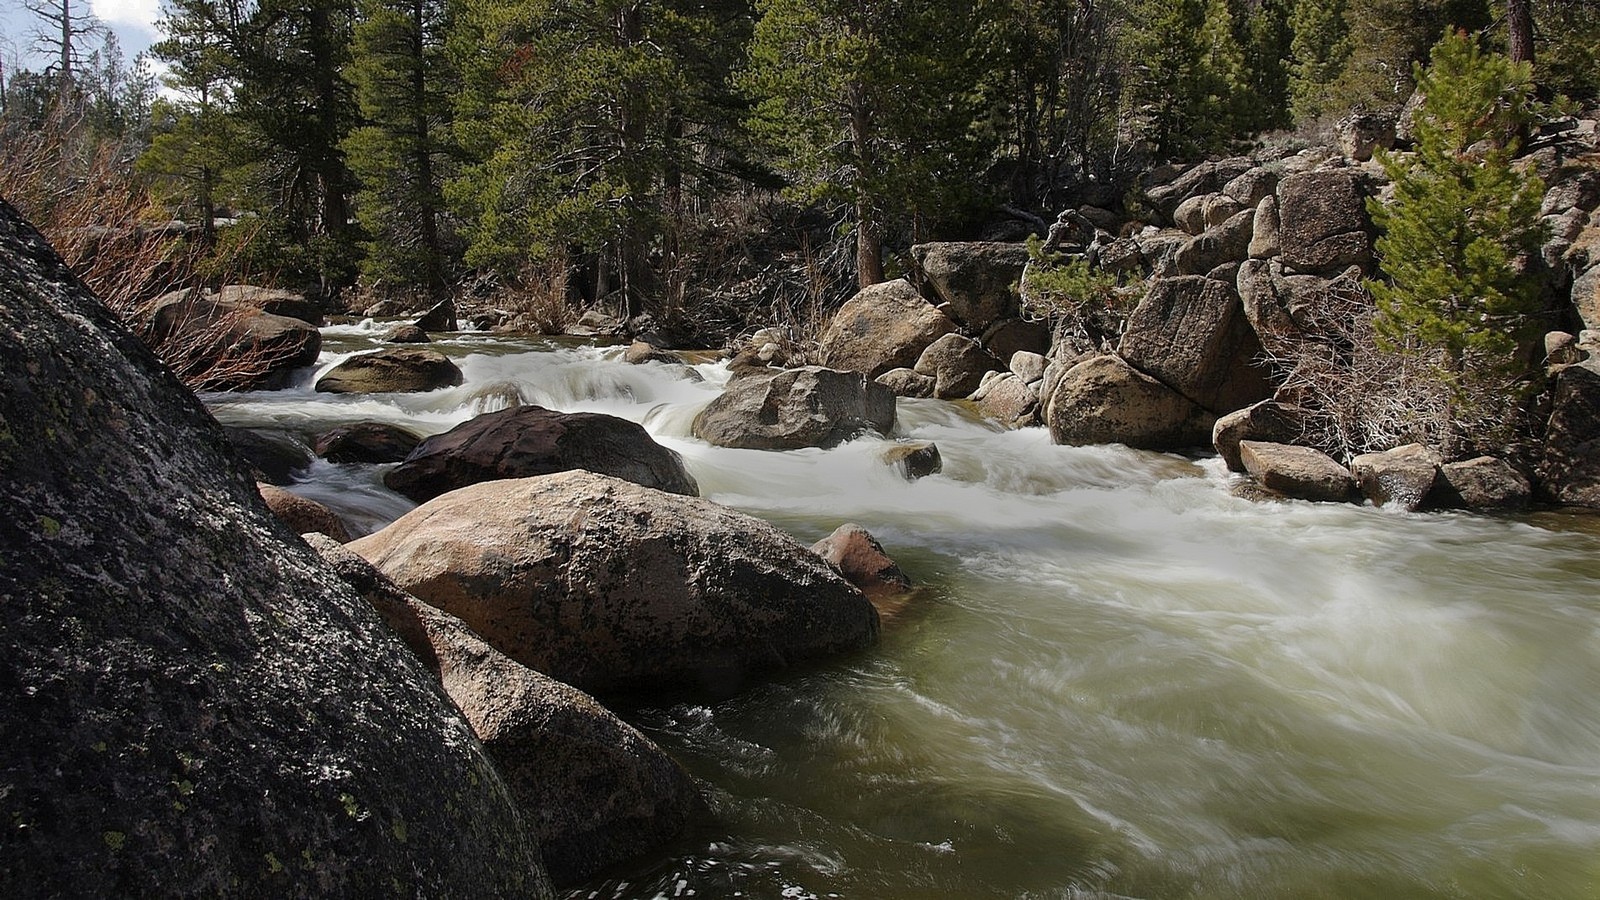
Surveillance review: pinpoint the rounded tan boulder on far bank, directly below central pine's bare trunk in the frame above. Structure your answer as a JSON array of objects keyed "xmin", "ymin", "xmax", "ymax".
[{"xmin": 821, "ymin": 279, "xmax": 955, "ymax": 378}]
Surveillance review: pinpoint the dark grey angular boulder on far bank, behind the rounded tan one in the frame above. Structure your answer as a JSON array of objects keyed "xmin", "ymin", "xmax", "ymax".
[{"xmin": 910, "ymin": 242, "xmax": 1027, "ymax": 335}]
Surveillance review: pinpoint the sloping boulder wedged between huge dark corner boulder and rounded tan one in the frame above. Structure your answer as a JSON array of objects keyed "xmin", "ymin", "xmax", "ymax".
[{"xmin": 310, "ymin": 536, "xmax": 706, "ymax": 887}]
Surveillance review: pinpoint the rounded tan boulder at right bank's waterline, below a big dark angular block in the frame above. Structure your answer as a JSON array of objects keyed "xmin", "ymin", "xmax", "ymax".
[{"xmin": 1045, "ymin": 354, "xmax": 1216, "ymax": 450}]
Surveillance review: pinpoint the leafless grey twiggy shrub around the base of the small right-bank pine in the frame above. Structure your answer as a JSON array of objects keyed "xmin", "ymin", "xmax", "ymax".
[{"xmin": 1262, "ymin": 280, "xmax": 1526, "ymax": 461}]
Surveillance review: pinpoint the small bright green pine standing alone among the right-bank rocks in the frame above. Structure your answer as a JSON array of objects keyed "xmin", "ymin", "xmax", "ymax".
[{"xmin": 1370, "ymin": 32, "xmax": 1544, "ymax": 386}]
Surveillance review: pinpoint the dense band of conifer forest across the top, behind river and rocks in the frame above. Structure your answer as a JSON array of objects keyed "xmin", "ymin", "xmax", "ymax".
[{"xmin": 0, "ymin": 0, "xmax": 1600, "ymax": 335}]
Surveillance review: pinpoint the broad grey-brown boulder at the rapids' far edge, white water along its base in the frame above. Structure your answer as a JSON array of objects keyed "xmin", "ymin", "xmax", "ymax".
[{"xmin": 693, "ymin": 365, "xmax": 894, "ymax": 450}]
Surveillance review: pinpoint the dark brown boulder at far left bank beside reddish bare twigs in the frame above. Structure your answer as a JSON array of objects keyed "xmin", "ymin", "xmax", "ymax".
[{"xmin": 139, "ymin": 291, "xmax": 322, "ymax": 391}]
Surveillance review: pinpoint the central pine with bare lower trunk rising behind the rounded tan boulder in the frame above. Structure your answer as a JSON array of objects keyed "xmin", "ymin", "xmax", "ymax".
[{"xmin": 741, "ymin": 0, "xmax": 981, "ymax": 287}]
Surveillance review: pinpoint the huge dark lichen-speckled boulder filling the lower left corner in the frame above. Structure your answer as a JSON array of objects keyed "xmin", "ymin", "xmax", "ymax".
[{"xmin": 0, "ymin": 202, "xmax": 550, "ymax": 897}]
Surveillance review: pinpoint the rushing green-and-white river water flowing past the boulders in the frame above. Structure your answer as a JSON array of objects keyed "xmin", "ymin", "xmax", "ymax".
[{"xmin": 206, "ymin": 323, "xmax": 1600, "ymax": 900}]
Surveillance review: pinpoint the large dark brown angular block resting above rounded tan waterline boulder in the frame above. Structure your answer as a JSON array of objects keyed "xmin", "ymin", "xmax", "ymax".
[{"xmin": 1118, "ymin": 275, "xmax": 1272, "ymax": 415}]
